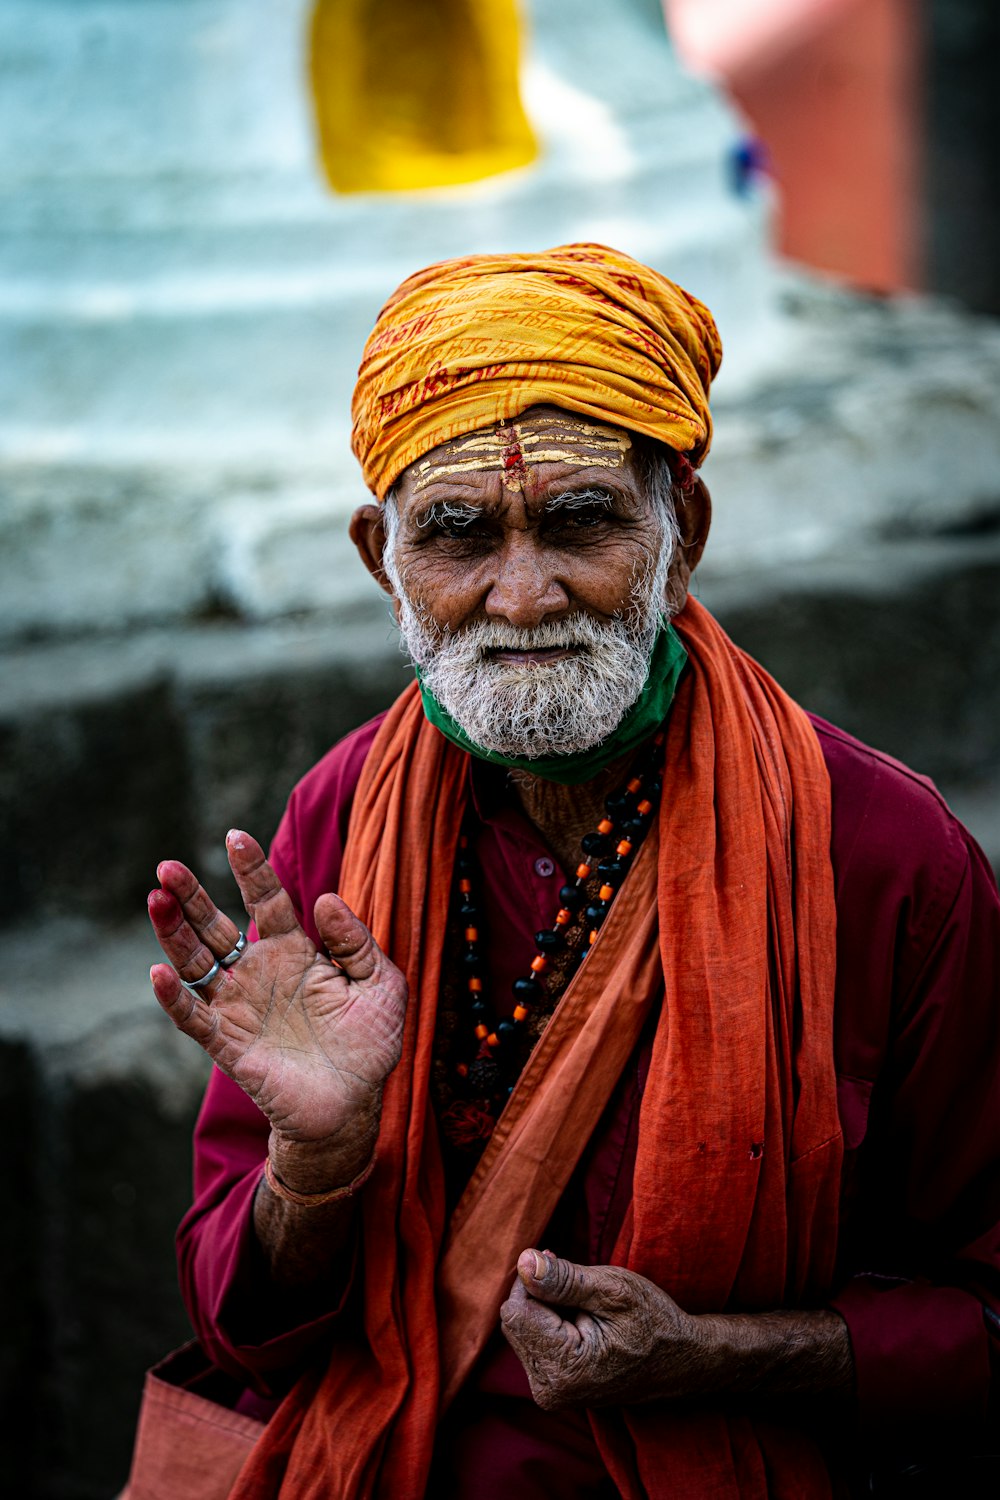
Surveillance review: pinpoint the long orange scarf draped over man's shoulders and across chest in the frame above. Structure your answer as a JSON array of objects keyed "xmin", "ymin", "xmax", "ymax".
[{"xmin": 232, "ymin": 602, "xmax": 841, "ymax": 1500}]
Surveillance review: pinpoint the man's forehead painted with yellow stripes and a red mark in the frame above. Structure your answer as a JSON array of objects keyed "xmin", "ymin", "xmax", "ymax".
[{"xmin": 405, "ymin": 407, "xmax": 633, "ymax": 494}]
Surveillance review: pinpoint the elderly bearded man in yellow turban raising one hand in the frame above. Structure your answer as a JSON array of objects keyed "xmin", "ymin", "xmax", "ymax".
[{"xmin": 150, "ymin": 246, "xmax": 1000, "ymax": 1500}]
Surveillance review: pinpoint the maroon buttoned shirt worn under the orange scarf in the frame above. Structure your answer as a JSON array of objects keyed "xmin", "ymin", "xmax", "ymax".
[{"xmin": 178, "ymin": 719, "xmax": 1000, "ymax": 1500}]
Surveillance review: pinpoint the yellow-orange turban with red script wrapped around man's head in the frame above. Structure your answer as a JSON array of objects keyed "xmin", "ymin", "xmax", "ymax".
[{"xmin": 351, "ymin": 245, "xmax": 723, "ymax": 498}]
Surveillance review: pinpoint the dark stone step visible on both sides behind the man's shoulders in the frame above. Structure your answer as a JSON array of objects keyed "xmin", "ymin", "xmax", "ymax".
[{"xmin": 0, "ymin": 531, "xmax": 1000, "ymax": 921}]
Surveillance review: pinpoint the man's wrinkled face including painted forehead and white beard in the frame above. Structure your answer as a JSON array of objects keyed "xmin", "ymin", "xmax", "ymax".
[{"xmin": 374, "ymin": 407, "xmax": 672, "ymax": 756}]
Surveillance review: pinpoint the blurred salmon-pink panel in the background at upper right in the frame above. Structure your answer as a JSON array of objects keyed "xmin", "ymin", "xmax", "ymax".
[{"xmin": 664, "ymin": 0, "xmax": 922, "ymax": 290}]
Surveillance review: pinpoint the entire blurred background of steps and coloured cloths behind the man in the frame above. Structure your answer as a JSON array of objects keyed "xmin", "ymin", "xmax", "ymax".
[{"xmin": 0, "ymin": 0, "xmax": 1000, "ymax": 1500}]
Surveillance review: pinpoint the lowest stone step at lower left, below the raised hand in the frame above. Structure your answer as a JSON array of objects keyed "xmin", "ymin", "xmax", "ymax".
[{"xmin": 0, "ymin": 918, "xmax": 207, "ymax": 1500}]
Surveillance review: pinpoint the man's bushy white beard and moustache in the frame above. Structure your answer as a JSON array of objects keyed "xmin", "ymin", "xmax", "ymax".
[{"xmin": 387, "ymin": 537, "xmax": 672, "ymax": 759}]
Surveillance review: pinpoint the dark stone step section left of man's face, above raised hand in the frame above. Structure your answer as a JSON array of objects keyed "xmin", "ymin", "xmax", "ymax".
[{"xmin": 0, "ymin": 611, "xmax": 406, "ymax": 921}]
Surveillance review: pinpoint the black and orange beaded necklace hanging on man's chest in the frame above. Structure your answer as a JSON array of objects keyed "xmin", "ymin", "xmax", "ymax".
[{"xmin": 441, "ymin": 731, "xmax": 666, "ymax": 1154}]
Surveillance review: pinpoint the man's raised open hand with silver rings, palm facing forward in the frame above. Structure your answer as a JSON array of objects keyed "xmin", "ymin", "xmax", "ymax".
[{"xmin": 148, "ymin": 830, "xmax": 406, "ymax": 1158}]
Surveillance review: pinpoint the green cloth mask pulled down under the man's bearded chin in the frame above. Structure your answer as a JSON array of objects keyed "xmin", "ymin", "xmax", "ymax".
[{"xmin": 417, "ymin": 621, "xmax": 688, "ymax": 786}]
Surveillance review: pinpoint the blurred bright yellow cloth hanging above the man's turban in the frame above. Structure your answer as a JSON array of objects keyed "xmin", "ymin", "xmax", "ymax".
[{"xmin": 310, "ymin": 0, "xmax": 537, "ymax": 192}]
